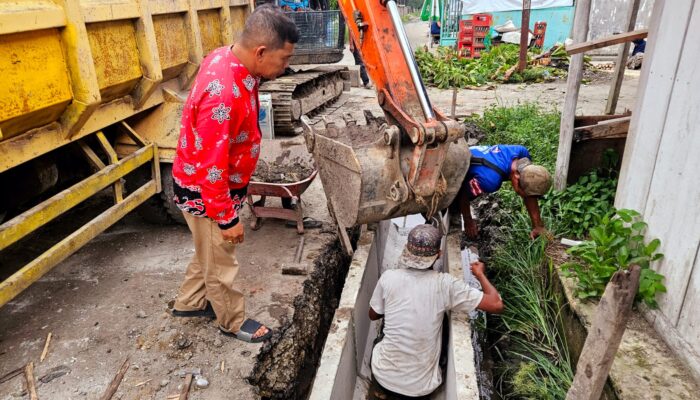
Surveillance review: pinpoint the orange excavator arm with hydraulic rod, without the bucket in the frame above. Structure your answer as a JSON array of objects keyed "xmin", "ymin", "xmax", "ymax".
[{"xmin": 338, "ymin": 0, "xmax": 464, "ymax": 196}]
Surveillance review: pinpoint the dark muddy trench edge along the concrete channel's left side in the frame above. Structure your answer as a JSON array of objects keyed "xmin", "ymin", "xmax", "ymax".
[{"xmin": 248, "ymin": 236, "xmax": 351, "ymax": 399}]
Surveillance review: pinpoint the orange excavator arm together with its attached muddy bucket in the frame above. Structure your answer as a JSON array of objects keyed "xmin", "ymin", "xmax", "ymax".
[{"xmin": 306, "ymin": 0, "xmax": 469, "ymax": 231}]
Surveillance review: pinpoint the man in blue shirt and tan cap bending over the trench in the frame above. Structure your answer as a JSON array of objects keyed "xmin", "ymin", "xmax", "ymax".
[{"xmin": 456, "ymin": 144, "xmax": 552, "ymax": 239}]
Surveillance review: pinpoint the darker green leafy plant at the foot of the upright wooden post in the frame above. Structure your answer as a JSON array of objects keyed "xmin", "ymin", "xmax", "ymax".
[{"xmin": 542, "ymin": 172, "xmax": 617, "ymax": 238}]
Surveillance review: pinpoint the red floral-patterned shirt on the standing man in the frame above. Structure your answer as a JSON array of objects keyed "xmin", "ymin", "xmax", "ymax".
[{"xmin": 173, "ymin": 46, "xmax": 260, "ymax": 229}]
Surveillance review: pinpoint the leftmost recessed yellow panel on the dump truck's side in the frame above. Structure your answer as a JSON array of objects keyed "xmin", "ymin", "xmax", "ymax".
[{"xmin": 0, "ymin": 29, "xmax": 72, "ymax": 139}]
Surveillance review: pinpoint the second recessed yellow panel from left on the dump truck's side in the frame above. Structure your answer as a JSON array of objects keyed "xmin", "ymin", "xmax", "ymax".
[{"xmin": 87, "ymin": 20, "xmax": 142, "ymax": 101}]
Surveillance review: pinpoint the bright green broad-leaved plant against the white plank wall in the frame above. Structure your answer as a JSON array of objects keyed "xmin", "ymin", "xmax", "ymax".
[{"xmin": 562, "ymin": 210, "xmax": 666, "ymax": 308}]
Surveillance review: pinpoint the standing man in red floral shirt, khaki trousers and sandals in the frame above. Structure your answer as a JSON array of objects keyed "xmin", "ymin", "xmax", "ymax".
[{"xmin": 173, "ymin": 5, "xmax": 299, "ymax": 342}]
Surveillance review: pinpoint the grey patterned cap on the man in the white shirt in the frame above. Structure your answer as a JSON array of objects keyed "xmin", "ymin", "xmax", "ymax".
[{"xmin": 399, "ymin": 224, "xmax": 442, "ymax": 269}]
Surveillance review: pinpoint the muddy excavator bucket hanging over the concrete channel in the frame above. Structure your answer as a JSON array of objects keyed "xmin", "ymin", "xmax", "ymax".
[{"xmin": 304, "ymin": 113, "xmax": 469, "ymax": 227}]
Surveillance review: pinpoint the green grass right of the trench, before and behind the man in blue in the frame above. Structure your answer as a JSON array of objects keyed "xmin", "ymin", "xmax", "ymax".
[{"xmin": 472, "ymin": 103, "xmax": 573, "ymax": 399}]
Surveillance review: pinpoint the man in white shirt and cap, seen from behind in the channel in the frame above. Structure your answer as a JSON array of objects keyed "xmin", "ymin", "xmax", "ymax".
[{"xmin": 369, "ymin": 225, "xmax": 503, "ymax": 400}]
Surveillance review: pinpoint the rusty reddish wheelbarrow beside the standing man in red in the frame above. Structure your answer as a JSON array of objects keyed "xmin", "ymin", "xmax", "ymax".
[{"xmin": 248, "ymin": 170, "xmax": 318, "ymax": 235}]
